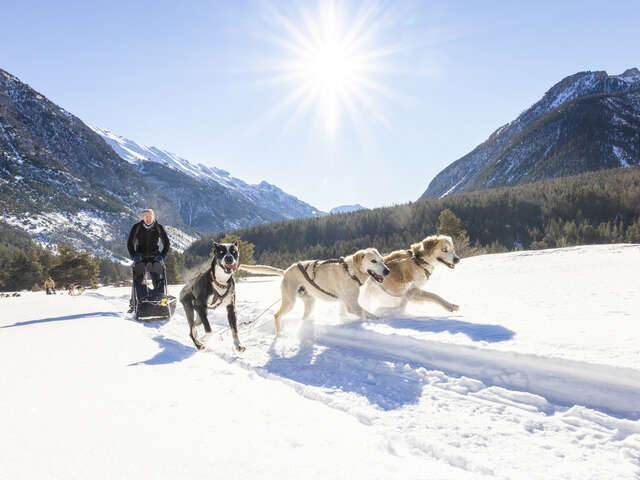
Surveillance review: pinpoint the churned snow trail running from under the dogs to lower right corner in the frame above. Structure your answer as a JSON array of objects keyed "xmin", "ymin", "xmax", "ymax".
[{"xmin": 96, "ymin": 274, "xmax": 640, "ymax": 479}]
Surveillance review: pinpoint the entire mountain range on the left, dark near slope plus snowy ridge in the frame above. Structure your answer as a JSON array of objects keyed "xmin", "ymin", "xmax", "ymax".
[{"xmin": 0, "ymin": 70, "xmax": 318, "ymax": 257}]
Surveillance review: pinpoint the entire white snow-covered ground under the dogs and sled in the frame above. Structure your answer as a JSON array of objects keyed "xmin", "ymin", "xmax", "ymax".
[{"xmin": 0, "ymin": 245, "xmax": 640, "ymax": 480}]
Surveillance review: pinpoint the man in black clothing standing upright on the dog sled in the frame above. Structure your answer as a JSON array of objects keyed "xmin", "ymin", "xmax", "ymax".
[{"xmin": 127, "ymin": 208, "xmax": 170, "ymax": 313}]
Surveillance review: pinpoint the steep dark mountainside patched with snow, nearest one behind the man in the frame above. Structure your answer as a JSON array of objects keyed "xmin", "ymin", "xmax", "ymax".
[{"xmin": 0, "ymin": 66, "xmax": 196, "ymax": 257}]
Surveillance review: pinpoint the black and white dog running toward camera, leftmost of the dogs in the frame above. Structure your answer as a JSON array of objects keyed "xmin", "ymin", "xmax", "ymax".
[{"xmin": 180, "ymin": 242, "xmax": 244, "ymax": 352}]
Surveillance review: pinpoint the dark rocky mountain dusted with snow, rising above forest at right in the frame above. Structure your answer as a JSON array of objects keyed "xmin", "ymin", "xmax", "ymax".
[{"xmin": 421, "ymin": 68, "xmax": 640, "ymax": 198}]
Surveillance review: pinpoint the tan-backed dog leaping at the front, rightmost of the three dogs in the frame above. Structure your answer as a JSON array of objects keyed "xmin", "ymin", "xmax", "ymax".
[{"xmin": 363, "ymin": 235, "xmax": 460, "ymax": 315}]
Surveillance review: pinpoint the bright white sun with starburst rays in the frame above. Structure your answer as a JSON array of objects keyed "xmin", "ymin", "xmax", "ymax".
[{"xmin": 258, "ymin": 0, "xmax": 397, "ymax": 137}]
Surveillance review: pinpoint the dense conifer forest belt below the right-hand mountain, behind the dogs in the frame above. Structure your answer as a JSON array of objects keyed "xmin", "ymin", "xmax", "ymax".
[{"xmin": 185, "ymin": 167, "xmax": 640, "ymax": 267}]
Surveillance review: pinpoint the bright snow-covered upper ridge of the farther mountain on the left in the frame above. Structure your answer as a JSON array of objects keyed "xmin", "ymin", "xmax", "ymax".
[{"xmin": 91, "ymin": 127, "xmax": 322, "ymax": 220}]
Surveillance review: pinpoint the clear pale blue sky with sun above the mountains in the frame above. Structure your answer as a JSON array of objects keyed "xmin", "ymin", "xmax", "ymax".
[{"xmin": 0, "ymin": 0, "xmax": 640, "ymax": 210}]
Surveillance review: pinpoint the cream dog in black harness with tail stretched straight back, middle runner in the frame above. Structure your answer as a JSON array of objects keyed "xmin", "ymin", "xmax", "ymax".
[{"xmin": 240, "ymin": 248, "xmax": 389, "ymax": 332}]
